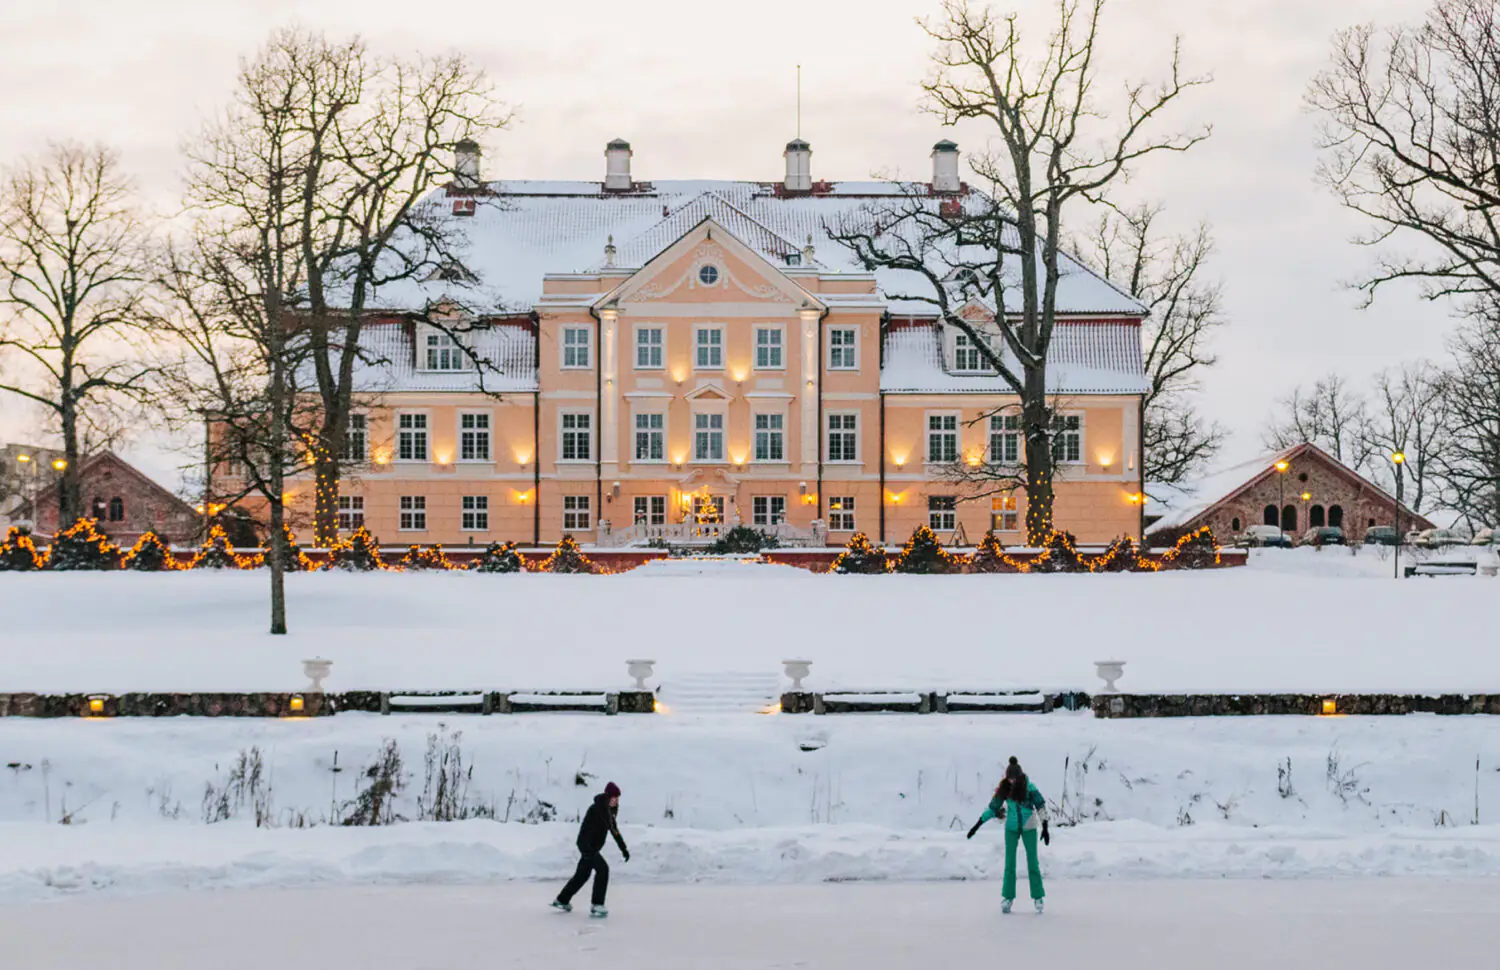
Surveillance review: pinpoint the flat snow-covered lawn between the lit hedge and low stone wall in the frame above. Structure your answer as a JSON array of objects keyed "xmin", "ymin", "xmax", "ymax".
[{"xmin": 0, "ymin": 549, "xmax": 1500, "ymax": 693}]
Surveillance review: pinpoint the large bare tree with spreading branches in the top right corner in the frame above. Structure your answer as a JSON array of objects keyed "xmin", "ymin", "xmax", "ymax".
[{"xmin": 1308, "ymin": 0, "xmax": 1500, "ymax": 307}]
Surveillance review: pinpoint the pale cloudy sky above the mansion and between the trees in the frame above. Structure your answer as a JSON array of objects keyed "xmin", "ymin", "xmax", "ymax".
[{"xmin": 0, "ymin": 0, "xmax": 1451, "ymax": 486}]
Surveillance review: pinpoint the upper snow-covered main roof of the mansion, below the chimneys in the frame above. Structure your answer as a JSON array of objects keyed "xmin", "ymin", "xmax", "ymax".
[{"xmin": 363, "ymin": 180, "xmax": 1146, "ymax": 316}]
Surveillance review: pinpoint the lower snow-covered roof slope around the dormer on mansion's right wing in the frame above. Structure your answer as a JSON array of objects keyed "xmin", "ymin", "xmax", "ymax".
[{"xmin": 881, "ymin": 321, "xmax": 1149, "ymax": 394}]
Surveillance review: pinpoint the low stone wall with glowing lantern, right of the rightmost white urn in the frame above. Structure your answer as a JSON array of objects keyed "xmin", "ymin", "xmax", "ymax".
[{"xmin": 1094, "ymin": 694, "xmax": 1500, "ymax": 718}]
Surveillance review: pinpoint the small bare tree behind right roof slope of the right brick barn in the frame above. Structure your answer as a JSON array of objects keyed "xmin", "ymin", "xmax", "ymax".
[{"xmin": 1362, "ymin": 361, "xmax": 1451, "ymax": 513}]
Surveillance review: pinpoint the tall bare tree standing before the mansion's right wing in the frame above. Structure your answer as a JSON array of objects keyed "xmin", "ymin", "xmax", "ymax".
[{"xmin": 830, "ymin": 0, "xmax": 1208, "ymax": 541}]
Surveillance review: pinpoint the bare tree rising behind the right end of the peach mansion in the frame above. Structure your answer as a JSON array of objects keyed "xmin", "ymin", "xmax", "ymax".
[{"xmin": 1079, "ymin": 205, "xmax": 1229, "ymax": 483}]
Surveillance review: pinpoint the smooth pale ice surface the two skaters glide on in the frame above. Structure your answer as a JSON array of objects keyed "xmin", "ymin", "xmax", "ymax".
[{"xmin": 0, "ymin": 877, "xmax": 1500, "ymax": 970}]
